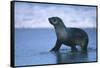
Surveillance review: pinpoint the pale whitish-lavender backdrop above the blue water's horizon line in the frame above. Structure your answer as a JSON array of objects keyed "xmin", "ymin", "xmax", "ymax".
[{"xmin": 15, "ymin": 2, "xmax": 96, "ymax": 28}]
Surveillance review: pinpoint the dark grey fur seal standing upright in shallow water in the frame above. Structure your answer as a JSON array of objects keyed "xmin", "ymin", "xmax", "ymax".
[{"xmin": 48, "ymin": 17, "xmax": 88, "ymax": 52}]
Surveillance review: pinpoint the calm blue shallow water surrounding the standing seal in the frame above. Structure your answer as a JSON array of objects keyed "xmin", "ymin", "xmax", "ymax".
[{"xmin": 15, "ymin": 29, "xmax": 96, "ymax": 66}]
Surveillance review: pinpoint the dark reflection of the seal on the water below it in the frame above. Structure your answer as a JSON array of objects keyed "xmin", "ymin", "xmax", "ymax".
[{"xmin": 50, "ymin": 51, "xmax": 88, "ymax": 64}]
